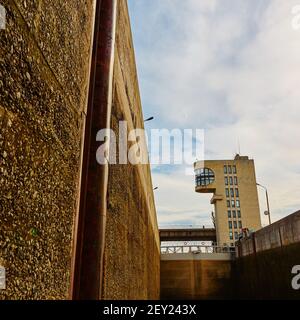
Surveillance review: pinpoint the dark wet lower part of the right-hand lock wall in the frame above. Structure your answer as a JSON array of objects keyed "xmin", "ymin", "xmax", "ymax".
[{"xmin": 233, "ymin": 243, "xmax": 300, "ymax": 300}]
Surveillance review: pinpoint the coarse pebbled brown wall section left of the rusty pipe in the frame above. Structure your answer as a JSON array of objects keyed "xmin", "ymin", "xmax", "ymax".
[{"xmin": 0, "ymin": 0, "xmax": 93, "ymax": 299}]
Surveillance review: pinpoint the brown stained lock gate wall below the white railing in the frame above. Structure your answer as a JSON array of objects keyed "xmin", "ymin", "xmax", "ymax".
[{"xmin": 161, "ymin": 254, "xmax": 233, "ymax": 300}]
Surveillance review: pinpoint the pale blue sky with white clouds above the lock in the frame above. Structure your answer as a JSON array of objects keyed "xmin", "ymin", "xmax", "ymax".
[{"xmin": 128, "ymin": 0, "xmax": 300, "ymax": 225}]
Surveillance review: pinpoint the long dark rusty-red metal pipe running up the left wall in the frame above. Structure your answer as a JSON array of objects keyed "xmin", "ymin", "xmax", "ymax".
[{"xmin": 72, "ymin": 0, "xmax": 117, "ymax": 300}]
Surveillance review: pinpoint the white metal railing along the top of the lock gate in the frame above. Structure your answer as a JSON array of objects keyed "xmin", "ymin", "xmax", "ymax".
[{"xmin": 160, "ymin": 245, "xmax": 235, "ymax": 254}]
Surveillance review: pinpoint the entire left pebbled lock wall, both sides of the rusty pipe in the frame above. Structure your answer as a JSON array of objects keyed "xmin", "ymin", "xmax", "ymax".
[{"xmin": 0, "ymin": 0, "xmax": 159, "ymax": 299}]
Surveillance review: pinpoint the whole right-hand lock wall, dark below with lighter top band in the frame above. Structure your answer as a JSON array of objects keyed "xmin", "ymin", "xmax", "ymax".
[{"xmin": 234, "ymin": 211, "xmax": 300, "ymax": 299}]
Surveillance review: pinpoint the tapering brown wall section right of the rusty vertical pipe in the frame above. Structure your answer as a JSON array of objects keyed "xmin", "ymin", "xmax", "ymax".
[{"xmin": 103, "ymin": 0, "xmax": 160, "ymax": 299}]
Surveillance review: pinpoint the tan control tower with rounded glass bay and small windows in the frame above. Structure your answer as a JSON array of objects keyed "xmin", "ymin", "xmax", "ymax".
[{"xmin": 194, "ymin": 155, "xmax": 261, "ymax": 245}]
